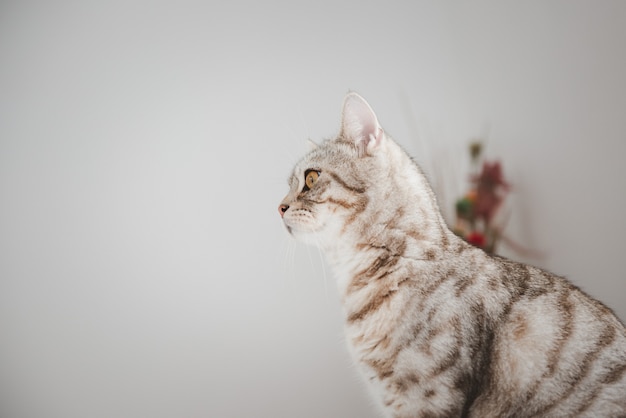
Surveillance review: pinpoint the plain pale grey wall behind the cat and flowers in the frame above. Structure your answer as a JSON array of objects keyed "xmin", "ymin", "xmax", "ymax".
[{"xmin": 0, "ymin": 0, "xmax": 626, "ymax": 418}]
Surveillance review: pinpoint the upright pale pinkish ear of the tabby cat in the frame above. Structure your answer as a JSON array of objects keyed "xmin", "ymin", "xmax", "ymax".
[{"xmin": 340, "ymin": 92, "xmax": 384, "ymax": 155}]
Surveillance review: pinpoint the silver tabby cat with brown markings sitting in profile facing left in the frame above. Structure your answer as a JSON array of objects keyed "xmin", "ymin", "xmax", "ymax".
[{"xmin": 278, "ymin": 93, "xmax": 626, "ymax": 418}]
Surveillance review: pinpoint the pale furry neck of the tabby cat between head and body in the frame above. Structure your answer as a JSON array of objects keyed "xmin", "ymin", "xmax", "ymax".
[{"xmin": 323, "ymin": 143, "xmax": 462, "ymax": 298}]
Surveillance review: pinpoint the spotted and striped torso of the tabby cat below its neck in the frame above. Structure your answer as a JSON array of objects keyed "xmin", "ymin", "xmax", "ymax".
[{"xmin": 344, "ymin": 240, "xmax": 626, "ymax": 418}]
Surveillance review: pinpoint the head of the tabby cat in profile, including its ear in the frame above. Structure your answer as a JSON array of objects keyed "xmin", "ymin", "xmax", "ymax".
[{"xmin": 278, "ymin": 93, "xmax": 404, "ymax": 246}]
